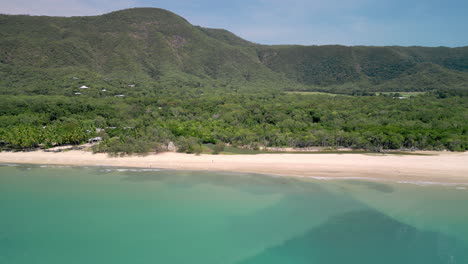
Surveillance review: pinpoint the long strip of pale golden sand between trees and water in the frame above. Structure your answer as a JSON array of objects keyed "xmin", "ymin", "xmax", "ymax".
[{"xmin": 0, "ymin": 150, "xmax": 468, "ymax": 184}]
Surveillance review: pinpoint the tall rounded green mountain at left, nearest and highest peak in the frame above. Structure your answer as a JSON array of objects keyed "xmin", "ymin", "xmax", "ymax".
[{"xmin": 0, "ymin": 8, "xmax": 286, "ymax": 96}]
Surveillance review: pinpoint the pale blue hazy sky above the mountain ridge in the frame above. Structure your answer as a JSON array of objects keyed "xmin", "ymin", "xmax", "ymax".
[{"xmin": 0, "ymin": 0, "xmax": 468, "ymax": 47}]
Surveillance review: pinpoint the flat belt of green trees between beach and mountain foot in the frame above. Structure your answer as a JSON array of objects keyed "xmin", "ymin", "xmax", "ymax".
[{"xmin": 0, "ymin": 88, "xmax": 468, "ymax": 154}]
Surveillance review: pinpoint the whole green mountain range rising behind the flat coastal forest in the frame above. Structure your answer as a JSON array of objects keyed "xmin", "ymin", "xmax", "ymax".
[{"xmin": 0, "ymin": 8, "xmax": 468, "ymax": 94}]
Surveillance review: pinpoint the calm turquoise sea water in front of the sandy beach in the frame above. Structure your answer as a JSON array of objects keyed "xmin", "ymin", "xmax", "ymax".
[{"xmin": 0, "ymin": 166, "xmax": 468, "ymax": 264}]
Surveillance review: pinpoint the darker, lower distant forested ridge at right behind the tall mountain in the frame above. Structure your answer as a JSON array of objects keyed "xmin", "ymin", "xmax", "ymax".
[{"xmin": 259, "ymin": 45, "xmax": 468, "ymax": 91}]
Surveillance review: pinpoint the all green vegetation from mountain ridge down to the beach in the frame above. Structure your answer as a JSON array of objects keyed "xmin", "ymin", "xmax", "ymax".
[{"xmin": 0, "ymin": 8, "xmax": 468, "ymax": 154}]
